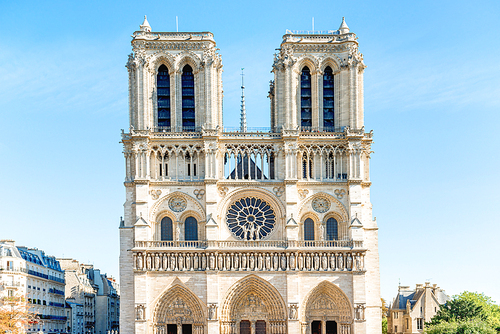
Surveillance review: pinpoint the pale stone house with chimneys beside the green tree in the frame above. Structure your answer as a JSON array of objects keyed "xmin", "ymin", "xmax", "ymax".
[{"xmin": 387, "ymin": 282, "xmax": 450, "ymax": 334}]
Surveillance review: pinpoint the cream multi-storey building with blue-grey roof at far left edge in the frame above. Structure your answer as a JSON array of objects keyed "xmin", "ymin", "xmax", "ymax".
[{"xmin": 0, "ymin": 240, "xmax": 67, "ymax": 334}]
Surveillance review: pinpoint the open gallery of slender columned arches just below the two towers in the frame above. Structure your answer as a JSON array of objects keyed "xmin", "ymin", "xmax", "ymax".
[{"xmin": 125, "ymin": 143, "xmax": 369, "ymax": 182}]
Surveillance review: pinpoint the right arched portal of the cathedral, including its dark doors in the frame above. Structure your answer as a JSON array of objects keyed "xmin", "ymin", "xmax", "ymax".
[{"xmin": 301, "ymin": 281, "xmax": 353, "ymax": 334}]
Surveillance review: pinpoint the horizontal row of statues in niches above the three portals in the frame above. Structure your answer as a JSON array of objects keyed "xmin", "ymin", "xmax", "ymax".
[{"xmin": 134, "ymin": 252, "xmax": 364, "ymax": 271}]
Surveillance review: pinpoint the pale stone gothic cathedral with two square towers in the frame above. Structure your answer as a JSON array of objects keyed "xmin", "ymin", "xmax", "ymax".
[{"xmin": 120, "ymin": 19, "xmax": 381, "ymax": 334}]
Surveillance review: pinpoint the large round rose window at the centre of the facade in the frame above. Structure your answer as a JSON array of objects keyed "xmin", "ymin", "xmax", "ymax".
[{"xmin": 226, "ymin": 197, "xmax": 276, "ymax": 240}]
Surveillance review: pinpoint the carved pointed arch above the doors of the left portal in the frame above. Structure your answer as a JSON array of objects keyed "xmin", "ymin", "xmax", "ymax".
[{"xmin": 153, "ymin": 279, "xmax": 206, "ymax": 328}]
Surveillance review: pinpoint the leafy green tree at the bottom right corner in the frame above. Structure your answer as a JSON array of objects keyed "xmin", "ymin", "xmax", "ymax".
[{"xmin": 425, "ymin": 291, "xmax": 500, "ymax": 334}]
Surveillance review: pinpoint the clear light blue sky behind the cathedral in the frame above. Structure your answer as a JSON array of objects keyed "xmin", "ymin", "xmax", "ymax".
[{"xmin": 0, "ymin": 0, "xmax": 500, "ymax": 302}]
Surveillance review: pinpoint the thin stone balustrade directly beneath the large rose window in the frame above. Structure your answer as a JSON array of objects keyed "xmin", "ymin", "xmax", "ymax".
[{"xmin": 135, "ymin": 240, "xmax": 363, "ymax": 249}]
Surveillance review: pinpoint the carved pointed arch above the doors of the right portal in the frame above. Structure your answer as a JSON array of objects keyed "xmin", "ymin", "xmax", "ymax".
[{"xmin": 301, "ymin": 281, "xmax": 353, "ymax": 324}]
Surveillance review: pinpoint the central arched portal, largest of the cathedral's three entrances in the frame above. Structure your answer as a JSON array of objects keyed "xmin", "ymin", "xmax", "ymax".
[{"xmin": 221, "ymin": 275, "xmax": 287, "ymax": 334}]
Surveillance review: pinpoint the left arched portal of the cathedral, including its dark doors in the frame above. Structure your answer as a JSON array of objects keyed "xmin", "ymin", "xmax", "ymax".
[{"xmin": 153, "ymin": 285, "xmax": 205, "ymax": 334}]
